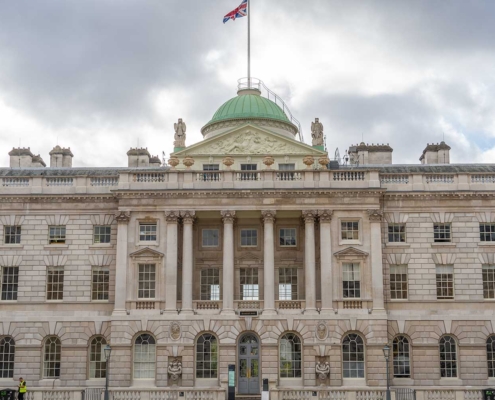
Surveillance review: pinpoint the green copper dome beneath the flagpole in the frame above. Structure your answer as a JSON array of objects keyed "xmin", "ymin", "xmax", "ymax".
[{"xmin": 207, "ymin": 89, "xmax": 290, "ymax": 125}]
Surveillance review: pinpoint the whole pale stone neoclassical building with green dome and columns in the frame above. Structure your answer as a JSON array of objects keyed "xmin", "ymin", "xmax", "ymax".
[{"xmin": 0, "ymin": 80, "xmax": 495, "ymax": 400}]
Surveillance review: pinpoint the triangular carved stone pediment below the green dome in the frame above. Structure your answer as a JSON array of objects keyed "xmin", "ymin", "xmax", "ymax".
[{"xmin": 174, "ymin": 124, "xmax": 326, "ymax": 157}]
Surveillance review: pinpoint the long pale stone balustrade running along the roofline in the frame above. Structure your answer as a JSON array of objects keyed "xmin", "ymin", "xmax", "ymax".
[{"xmin": 0, "ymin": 168, "xmax": 495, "ymax": 195}]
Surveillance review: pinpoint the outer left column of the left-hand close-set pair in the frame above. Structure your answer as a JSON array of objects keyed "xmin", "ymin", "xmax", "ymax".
[{"xmin": 165, "ymin": 211, "xmax": 179, "ymax": 314}]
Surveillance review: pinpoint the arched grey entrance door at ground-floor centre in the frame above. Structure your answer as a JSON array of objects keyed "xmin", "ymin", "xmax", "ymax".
[{"xmin": 237, "ymin": 333, "xmax": 260, "ymax": 394}]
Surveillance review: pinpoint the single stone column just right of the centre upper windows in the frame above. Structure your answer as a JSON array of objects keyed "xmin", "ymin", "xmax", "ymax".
[{"xmin": 261, "ymin": 210, "xmax": 277, "ymax": 315}]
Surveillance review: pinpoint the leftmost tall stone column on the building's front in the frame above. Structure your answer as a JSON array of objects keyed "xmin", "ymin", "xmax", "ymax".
[{"xmin": 113, "ymin": 211, "xmax": 131, "ymax": 315}]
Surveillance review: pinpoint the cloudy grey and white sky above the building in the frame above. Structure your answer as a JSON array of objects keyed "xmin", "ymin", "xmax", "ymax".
[{"xmin": 0, "ymin": 0, "xmax": 495, "ymax": 167}]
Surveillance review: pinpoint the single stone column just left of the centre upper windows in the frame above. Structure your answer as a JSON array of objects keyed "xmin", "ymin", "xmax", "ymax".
[{"xmin": 220, "ymin": 211, "xmax": 235, "ymax": 314}]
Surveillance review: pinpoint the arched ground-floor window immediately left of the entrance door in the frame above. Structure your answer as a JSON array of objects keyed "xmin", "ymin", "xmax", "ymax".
[{"xmin": 194, "ymin": 332, "xmax": 220, "ymax": 380}]
